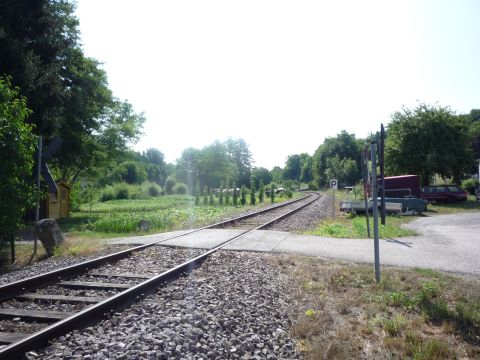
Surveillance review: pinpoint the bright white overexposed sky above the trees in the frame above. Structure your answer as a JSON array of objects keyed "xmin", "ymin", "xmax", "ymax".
[{"xmin": 76, "ymin": 0, "xmax": 480, "ymax": 169}]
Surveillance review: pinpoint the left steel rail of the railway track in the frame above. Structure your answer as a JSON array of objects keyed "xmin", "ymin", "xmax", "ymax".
[{"xmin": 0, "ymin": 195, "xmax": 310, "ymax": 301}]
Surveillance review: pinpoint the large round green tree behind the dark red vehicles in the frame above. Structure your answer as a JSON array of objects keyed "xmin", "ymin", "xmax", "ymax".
[{"xmin": 385, "ymin": 103, "xmax": 473, "ymax": 185}]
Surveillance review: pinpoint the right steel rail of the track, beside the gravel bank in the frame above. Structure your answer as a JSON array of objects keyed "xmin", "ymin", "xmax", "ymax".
[{"xmin": 0, "ymin": 191, "xmax": 320, "ymax": 359}]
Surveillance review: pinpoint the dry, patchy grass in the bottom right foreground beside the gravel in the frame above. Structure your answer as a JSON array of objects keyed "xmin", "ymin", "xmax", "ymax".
[{"xmin": 272, "ymin": 256, "xmax": 480, "ymax": 360}]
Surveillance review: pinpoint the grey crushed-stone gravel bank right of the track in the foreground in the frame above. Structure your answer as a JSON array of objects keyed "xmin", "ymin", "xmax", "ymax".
[{"xmin": 28, "ymin": 252, "xmax": 299, "ymax": 360}]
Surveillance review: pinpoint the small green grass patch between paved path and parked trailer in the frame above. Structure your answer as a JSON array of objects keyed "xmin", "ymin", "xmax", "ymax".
[{"xmin": 308, "ymin": 214, "xmax": 416, "ymax": 239}]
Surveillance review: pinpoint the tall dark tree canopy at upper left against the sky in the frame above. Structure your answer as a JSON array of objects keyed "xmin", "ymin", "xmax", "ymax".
[{"xmin": 0, "ymin": 0, "xmax": 145, "ymax": 183}]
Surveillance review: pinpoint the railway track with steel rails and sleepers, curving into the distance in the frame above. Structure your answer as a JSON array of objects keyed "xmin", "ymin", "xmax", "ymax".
[{"xmin": 0, "ymin": 194, "xmax": 318, "ymax": 359}]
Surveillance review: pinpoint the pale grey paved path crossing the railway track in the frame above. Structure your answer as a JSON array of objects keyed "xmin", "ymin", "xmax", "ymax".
[{"xmin": 109, "ymin": 212, "xmax": 480, "ymax": 275}]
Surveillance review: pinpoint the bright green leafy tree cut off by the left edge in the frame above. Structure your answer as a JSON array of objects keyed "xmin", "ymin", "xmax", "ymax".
[{"xmin": 0, "ymin": 77, "xmax": 37, "ymax": 265}]
